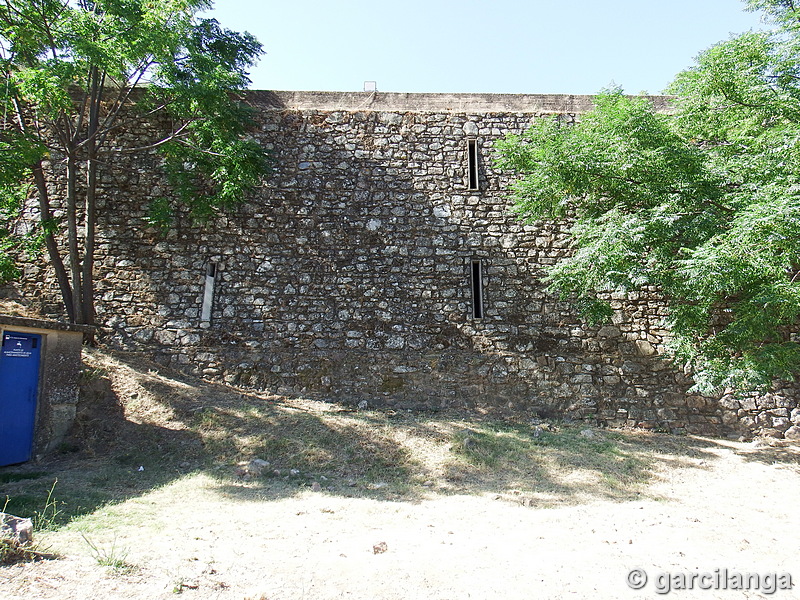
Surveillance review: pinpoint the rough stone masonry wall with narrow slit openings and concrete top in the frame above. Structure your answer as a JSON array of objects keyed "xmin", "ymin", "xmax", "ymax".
[{"xmin": 15, "ymin": 92, "xmax": 800, "ymax": 437}]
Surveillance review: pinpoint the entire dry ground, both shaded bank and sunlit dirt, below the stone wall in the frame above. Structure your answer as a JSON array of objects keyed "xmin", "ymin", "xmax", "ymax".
[{"xmin": 0, "ymin": 353, "xmax": 800, "ymax": 600}]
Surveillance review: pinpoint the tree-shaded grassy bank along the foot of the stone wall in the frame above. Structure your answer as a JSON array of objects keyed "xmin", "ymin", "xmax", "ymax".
[{"xmin": 0, "ymin": 351, "xmax": 798, "ymax": 528}]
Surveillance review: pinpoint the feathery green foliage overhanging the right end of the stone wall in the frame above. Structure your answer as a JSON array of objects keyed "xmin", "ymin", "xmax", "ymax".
[{"xmin": 498, "ymin": 0, "xmax": 800, "ymax": 391}]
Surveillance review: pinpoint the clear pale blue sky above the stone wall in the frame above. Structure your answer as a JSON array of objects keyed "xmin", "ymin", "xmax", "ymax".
[{"xmin": 206, "ymin": 0, "xmax": 764, "ymax": 94}]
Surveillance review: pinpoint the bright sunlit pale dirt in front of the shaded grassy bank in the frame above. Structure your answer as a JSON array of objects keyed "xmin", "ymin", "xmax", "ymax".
[{"xmin": 0, "ymin": 440, "xmax": 800, "ymax": 600}]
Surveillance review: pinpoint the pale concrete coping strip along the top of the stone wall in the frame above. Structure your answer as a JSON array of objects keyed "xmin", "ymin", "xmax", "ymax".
[{"xmin": 245, "ymin": 90, "xmax": 673, "ymax": 114}]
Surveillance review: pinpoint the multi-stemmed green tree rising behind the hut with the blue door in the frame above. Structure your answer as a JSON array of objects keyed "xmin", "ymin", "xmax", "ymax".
[{"xmin": 0, "ymin": 0, "xmax": 266, "ymax": 323}]
